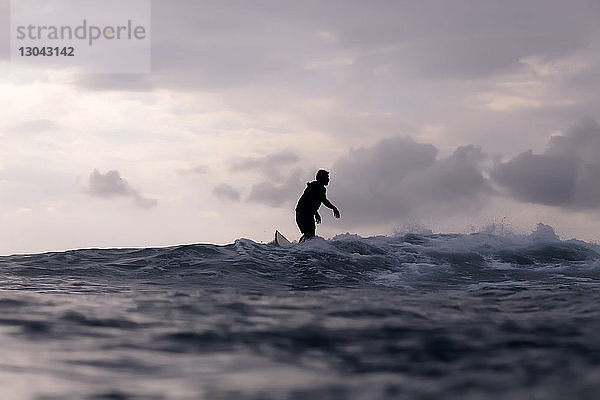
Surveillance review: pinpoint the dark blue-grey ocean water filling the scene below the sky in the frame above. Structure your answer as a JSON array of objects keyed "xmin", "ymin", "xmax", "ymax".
[{"xmin": 0, "ymin": 225, "xmax": 600, "ymax": 400}]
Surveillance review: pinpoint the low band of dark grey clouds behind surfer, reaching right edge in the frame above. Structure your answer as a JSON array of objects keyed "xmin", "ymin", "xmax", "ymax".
[{"xmin": 234, "ymin": 119, "xmax": 600, "ymax": 227}]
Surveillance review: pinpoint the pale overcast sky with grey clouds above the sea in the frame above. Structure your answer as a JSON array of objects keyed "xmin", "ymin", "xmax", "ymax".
[{"xmin": 0, "ymin": 0, "xmax": 600, "ymax": 254}]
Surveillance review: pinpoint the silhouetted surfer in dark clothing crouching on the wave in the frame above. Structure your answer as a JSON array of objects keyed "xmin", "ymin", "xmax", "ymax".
[{"xmin": 296, "ymin": 169, "xmax": 340, "ymax": 242}]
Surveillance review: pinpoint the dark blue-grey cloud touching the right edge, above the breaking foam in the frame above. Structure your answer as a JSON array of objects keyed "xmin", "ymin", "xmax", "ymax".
[{"xmin": 491, "ymin": 120, "xmax": 600, "ymax": 209}]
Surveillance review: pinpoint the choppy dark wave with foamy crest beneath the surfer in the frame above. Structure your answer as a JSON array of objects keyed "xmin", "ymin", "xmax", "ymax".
[{"xmin": 0, "ymin": 224, "xmax": 600, "ymax": 289}]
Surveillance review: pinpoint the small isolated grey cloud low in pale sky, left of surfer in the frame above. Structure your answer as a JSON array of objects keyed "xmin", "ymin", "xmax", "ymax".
[{"xmin": 86, "ymin": 169, "xmax": 158, "ymax": 208}]
